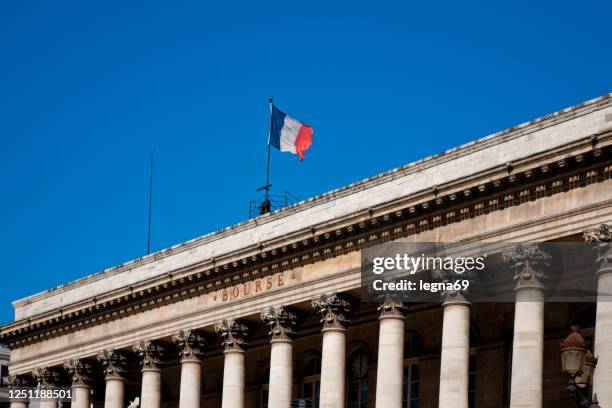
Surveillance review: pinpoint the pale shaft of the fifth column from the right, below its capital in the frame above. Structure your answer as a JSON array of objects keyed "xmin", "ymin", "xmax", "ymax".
[{"xmin": 319, "ymin": 328, "xmax": 346, "ymax": 408}]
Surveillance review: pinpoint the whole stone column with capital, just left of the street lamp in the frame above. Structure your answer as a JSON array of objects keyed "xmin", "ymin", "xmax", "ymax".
[{"xmin": 502, "ymin": 244, "xmax": 550, "ymax": 408}]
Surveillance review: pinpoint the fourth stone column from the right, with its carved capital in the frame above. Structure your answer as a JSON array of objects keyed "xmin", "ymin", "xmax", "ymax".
[{"xmin": 376, "ymin": 300, "xmax": 405, "ymax": 408}]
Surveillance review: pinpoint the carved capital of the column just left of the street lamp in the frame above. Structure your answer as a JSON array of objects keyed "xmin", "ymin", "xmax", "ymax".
[{"xmin": 502, "ymin": 243, "xmax": 551, "ymax": 290}]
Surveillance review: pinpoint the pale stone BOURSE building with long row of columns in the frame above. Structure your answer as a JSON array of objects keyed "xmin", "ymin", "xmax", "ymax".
[{"xmin": 0, "ymin": 94, "xmax": 612, "ymax": 408}]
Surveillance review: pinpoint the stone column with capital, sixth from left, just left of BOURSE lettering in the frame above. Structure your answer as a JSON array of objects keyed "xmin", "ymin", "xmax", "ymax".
[{"xmin": 172, "ymin": 330, "xmax": 204, "ymax": 408}]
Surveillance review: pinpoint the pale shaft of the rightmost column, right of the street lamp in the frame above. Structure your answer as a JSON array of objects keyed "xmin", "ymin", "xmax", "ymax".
[{"xmin": 593, "ymin": 270, "xmax": 612, "ymax": 407}]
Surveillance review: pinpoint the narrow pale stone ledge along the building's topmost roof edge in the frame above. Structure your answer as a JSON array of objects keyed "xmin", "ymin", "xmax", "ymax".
[{"xmin": 13, "ymin": 93, "xmax": 612, "ymax": 307}]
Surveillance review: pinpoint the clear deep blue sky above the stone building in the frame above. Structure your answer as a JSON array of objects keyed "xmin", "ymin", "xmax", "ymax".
[{"xmin": 0, "ymin": 1, "xmax": 612, "ymax": 322}]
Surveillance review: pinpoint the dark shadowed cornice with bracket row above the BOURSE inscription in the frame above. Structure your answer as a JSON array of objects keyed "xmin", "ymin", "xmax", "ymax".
[{"xmin": 0, "ymin": 134, "xmax": 612, "ymax": 347}]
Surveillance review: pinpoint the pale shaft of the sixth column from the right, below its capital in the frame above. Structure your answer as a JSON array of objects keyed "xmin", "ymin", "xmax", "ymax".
[{"xmin": 268, "ymin": 339, "xmax": 293, "ymax": 408}]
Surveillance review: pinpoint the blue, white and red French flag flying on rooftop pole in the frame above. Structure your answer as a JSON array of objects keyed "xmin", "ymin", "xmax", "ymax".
[{"xmin": 270, "ymin": 105, "xmax": 312, "ymax": 160}]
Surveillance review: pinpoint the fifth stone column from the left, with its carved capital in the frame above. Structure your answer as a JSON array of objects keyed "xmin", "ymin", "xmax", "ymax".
[{"xmin": 134, "ymin": 340, "xmax": 164, "ymax": 408}]
